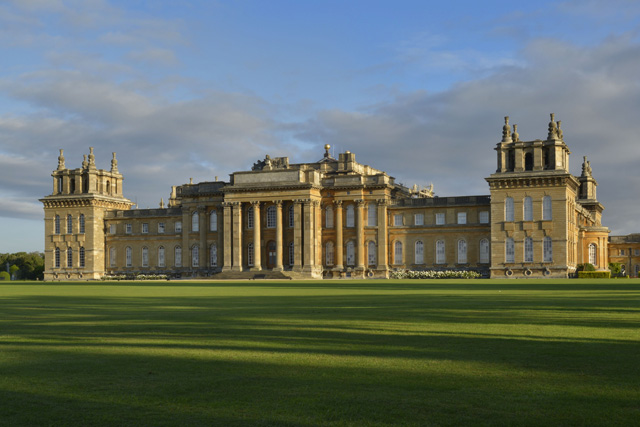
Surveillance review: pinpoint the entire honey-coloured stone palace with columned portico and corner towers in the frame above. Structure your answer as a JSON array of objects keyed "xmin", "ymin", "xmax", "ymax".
[{"xmin": 41, "ymin": 114, "xmax": 620, "ymax": 280}]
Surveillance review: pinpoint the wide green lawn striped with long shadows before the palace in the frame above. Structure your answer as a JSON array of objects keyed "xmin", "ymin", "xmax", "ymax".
[{"xmin": 0, "ymin": 280, "xmax": 640, "ymax": 426}]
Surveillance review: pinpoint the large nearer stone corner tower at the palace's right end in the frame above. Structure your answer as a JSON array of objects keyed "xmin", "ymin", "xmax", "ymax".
[{"xmin": 486, "ymin": 114, "xmax": 580, "ymax": 278}]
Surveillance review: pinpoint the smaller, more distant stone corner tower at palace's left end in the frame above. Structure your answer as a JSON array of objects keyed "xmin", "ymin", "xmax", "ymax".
[{"xmin": 40, "ymin": 147, "xmax": 133, "ymax": 280}]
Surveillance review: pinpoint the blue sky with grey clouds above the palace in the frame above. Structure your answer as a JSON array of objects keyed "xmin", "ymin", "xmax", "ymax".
[{"xmin": 0, "ymin": 0, "xmax": 640, "ymax": 252}]
